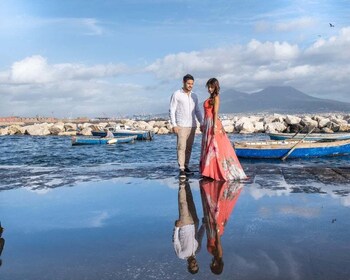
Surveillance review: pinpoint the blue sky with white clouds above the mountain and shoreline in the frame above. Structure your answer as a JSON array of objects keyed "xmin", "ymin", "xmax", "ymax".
[{"xmin": 0, "ymin": 0, "xmax": 350, "ymax": 118}]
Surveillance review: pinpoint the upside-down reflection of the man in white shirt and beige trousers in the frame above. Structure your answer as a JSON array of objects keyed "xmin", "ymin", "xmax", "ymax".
[{"xmin": 173, "ymin": 179, "xmax": 204, "ymax": 274}]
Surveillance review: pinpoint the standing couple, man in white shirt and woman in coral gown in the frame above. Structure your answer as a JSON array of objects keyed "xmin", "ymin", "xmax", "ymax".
[{"xmin": 169, "ymin": 74, "xmax": 247, "ymax": 181}]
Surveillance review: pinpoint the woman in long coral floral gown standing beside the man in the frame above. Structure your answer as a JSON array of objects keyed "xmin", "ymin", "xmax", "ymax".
[{"xmin": 200, "ymin": 78, "xmax": 247, "ymax": 181}]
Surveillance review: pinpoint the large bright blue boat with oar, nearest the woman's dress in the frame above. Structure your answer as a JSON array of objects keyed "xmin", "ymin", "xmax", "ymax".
[{"xmin": 233, "ymin": 139, "xmax": 350, "ymax": 159}]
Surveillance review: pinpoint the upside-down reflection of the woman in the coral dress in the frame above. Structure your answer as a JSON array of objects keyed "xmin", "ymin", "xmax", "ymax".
[{"xmin": 199, "ymin": 179, "xmax": 243, "ymax": 274}]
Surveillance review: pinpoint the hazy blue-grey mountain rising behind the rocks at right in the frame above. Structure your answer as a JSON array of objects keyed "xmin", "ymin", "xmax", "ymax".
[{"xmin": 220, "ymin": 86, "xmax": 350, "ymax": 114}]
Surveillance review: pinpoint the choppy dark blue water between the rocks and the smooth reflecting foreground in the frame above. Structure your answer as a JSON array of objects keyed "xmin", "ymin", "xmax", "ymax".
[{"xmin": 0, "ymin": 134, "xmax": 350, "ymax": 190}]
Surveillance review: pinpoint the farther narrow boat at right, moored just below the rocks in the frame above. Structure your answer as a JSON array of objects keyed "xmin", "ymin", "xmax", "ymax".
[{"xmin": 268, "ymin": 133, "xmax": 350, "ymax": 141}]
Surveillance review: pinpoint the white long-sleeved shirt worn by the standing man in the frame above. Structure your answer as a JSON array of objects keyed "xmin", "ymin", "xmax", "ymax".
[{"xmin": 169, "ymin": 89, "xmax": 203, "ymax": 127}]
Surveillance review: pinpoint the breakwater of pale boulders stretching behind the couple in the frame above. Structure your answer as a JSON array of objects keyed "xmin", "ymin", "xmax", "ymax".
[{"xmin": 0, "ymin": 114, "xmax": 350, "ymax": 136}]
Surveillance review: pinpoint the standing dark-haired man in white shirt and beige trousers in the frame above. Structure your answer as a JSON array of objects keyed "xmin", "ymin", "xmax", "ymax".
[{"xmin": 169, "ymin": 74, "xmax": 203, "ymax": 179}]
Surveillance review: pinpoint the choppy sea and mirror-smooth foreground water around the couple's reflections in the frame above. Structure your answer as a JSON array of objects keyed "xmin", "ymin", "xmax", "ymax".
[{"xmin": 0, "ymin": 134, "xmax": 350, "ymax": 280}]
